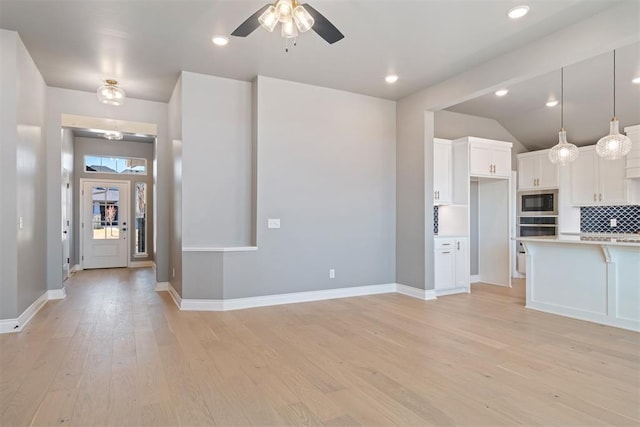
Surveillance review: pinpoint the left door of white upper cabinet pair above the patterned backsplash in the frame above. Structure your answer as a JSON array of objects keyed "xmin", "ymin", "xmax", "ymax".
[{"xmin": 570, "ymin": 148, "xmax": 598, "ymax": 206}]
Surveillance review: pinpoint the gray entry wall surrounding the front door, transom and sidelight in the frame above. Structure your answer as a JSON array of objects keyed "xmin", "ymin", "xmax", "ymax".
[{"xmin": 72, "ymin": 137, "xmax": 154, "ymax": 264}]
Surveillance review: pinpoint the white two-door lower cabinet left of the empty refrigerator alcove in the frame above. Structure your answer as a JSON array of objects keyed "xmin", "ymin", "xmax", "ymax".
[{"xmin": 434, "ymin": 237, "xmax": 469, "ymax": 295}]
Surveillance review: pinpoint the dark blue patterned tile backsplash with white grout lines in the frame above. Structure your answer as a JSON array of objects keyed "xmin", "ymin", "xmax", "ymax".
[{"xmin": 580, "ymin": 206, "xmax": 640, "ymax": 233}]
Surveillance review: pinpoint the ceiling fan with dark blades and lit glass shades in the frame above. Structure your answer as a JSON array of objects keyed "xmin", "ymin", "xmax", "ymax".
[{"xmin": 231, "ymin": 0, "xmax": 344, "ymax": 44}]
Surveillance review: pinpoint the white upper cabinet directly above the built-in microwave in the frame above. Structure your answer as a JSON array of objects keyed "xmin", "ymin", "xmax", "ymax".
[{"xmin": 518, "ymin": 150, "xmax": 559, "ymax": 190}]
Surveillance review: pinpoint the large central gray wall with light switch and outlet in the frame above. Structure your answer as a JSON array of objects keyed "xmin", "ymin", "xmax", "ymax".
[{"xmin": 224, "ymin": 76, "xmax": 396, "ymax": 299}]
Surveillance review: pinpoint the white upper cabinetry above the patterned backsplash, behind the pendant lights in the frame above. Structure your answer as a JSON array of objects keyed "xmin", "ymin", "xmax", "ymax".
[{"xmin": 571, "ymin": 145, "xmax": 640, "ymax": 206}]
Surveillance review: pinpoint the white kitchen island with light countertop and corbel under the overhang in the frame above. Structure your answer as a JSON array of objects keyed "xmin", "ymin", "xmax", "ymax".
[{"xmin": 518, "ymin": 234, "xmax": 640, "ymax": 331}]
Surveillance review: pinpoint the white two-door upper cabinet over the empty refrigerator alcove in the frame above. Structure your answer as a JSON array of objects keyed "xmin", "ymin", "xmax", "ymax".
[{"xmin": 467, "ymin": 137, "xmax": 512, "ymax": 178}]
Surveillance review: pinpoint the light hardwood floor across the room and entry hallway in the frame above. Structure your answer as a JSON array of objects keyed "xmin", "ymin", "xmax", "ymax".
[{"xmin": 0, "ymin": 269, "xmax": 640, "ymax": 426}]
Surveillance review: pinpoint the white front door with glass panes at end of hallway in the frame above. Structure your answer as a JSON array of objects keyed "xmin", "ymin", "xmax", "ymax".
[{"xmin": 81, "ymin": 180, "xmax": 129, "ymax": 269}]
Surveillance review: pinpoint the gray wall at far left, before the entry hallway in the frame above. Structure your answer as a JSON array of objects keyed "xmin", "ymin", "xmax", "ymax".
[{"xmin": 0, "ymin": 30, "xmax": 47, "ymax": 319}]
